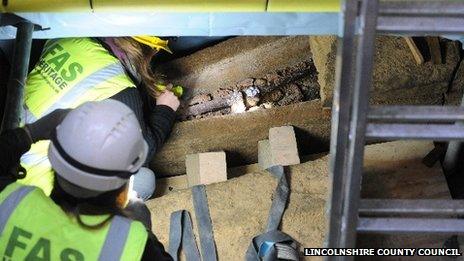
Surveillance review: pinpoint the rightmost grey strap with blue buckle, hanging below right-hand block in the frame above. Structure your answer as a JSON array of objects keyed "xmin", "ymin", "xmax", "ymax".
[{"xmin": 245, "ymin": 166, "xmax": 299, "ymax": 261}]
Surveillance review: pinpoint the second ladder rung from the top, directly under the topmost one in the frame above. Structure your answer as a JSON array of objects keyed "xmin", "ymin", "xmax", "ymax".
[{"xmin": 377, "ymin": 16, "xmax": 464, "ymax": 35}]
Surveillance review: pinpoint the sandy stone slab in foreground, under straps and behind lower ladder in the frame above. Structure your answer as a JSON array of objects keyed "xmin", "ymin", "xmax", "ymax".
[{"xmin": 148, "ymin": 141, "xmax": 449, "ymax": 260}]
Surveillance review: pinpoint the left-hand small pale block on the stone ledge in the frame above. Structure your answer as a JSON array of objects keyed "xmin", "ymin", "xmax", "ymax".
[{"xmin": 185, "ymin": 151, "xmax": 227, "ymax": 187}]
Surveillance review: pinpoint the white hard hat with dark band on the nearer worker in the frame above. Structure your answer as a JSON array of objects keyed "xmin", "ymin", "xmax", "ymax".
[{"xmin": 48, "ymin": 100, "xmax": 148, "ymax": 194}]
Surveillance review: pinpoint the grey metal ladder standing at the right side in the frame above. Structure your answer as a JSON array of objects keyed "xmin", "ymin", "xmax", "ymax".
[{"xmin": 327, "ymin": 0, "xmax": 464, "ymax": 253}]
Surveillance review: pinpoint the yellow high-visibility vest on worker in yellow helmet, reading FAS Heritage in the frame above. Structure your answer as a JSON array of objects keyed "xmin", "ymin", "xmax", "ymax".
[{"xmin": 19, "ymin": 38, "xmax": 135, "ymax": 195}]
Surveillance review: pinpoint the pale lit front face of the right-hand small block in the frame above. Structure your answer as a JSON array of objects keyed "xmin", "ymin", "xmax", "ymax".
[{"xmin": 269, "ymin": 126, "xmax": 300, "ymax": 166}]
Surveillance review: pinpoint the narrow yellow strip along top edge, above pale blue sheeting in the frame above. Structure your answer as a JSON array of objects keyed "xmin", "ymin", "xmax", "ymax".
[{"xmin": 1, "ymin": 0, "xmax": 340, "ymax": 12}]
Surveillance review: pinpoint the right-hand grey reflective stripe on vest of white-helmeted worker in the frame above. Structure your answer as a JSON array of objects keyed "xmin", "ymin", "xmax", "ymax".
[{"xmin": 98, "ymin": 216, "xmax": 132, "ymax": 261}]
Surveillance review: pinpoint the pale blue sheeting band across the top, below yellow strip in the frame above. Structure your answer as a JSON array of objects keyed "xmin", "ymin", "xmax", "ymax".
[{"xmin": 0, "ymin": 12, "xmax": 339, "ymax": 39}]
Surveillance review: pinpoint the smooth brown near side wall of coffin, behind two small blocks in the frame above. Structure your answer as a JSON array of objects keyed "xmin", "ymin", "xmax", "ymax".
[{"xmin": 151, "ymin": 101, "xmax": 330, "ymax": 176}]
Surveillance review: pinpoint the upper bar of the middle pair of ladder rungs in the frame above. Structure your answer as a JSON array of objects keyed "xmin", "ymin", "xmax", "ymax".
[{"xmin": 367, "ymin": 106, "xmax": 464, "ymax": 122}]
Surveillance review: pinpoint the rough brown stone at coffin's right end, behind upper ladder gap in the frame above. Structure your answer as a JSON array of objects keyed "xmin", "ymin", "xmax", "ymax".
[{"xmin": 310, "ymin": 36, "xmax": 459, "ymax": 106}]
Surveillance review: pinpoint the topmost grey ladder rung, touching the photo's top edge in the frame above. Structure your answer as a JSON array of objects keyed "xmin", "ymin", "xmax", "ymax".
[{"xmin": 379, "ymin": 0, "xmax": 464, "ymax": 17}]
